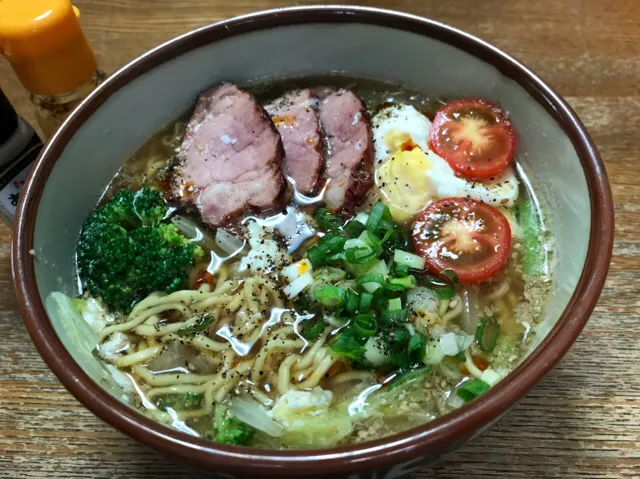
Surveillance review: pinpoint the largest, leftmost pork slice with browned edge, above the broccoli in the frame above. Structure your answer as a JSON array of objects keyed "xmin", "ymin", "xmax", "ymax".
[{"xmin": 172, "ymin": 83, "xmax": 285, "ymax": 226}]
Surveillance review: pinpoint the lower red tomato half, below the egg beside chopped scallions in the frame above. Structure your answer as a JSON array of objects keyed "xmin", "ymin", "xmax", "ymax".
[{"xmin": 413, "ymin": 198, "xmax": 511, "ymax": 283}]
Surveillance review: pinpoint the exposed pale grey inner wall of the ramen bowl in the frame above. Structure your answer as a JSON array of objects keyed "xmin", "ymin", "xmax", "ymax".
[{"xmin": 33, "ymin": 23, "xmax": 591, "ymax": 436}]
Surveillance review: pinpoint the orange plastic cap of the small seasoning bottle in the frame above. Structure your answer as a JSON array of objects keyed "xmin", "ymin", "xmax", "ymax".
[{"xmin": 0, "ymin": 0, "xmax": 97, "ymax": 95}]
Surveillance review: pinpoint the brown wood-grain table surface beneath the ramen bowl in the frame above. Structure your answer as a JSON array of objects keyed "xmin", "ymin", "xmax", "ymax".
[{"xmin": 0, "ymin": 0, "xmax": 640, "ymax": 479}]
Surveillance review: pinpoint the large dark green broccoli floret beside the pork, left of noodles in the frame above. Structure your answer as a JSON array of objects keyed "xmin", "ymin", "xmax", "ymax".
[{"xmin": 78, "ymin": 188, "xmax": 204, "ymax": 313}]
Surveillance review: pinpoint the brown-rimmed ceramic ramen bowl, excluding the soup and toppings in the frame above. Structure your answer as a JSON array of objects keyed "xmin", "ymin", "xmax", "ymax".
[{"xmin": 13, "ymin": 6, "xmax": 613, "ymax": 478}]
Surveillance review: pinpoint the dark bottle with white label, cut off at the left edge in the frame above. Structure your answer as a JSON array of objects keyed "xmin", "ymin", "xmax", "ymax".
[{"xmin": 0, "ymin": 90, "xmax": 42, "ymax": 224}]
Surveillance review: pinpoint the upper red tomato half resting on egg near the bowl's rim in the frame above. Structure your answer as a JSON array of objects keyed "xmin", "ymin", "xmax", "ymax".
[{"xmin": 431, "ymin": 99, "xmax": 516, "ymax": 179}]
